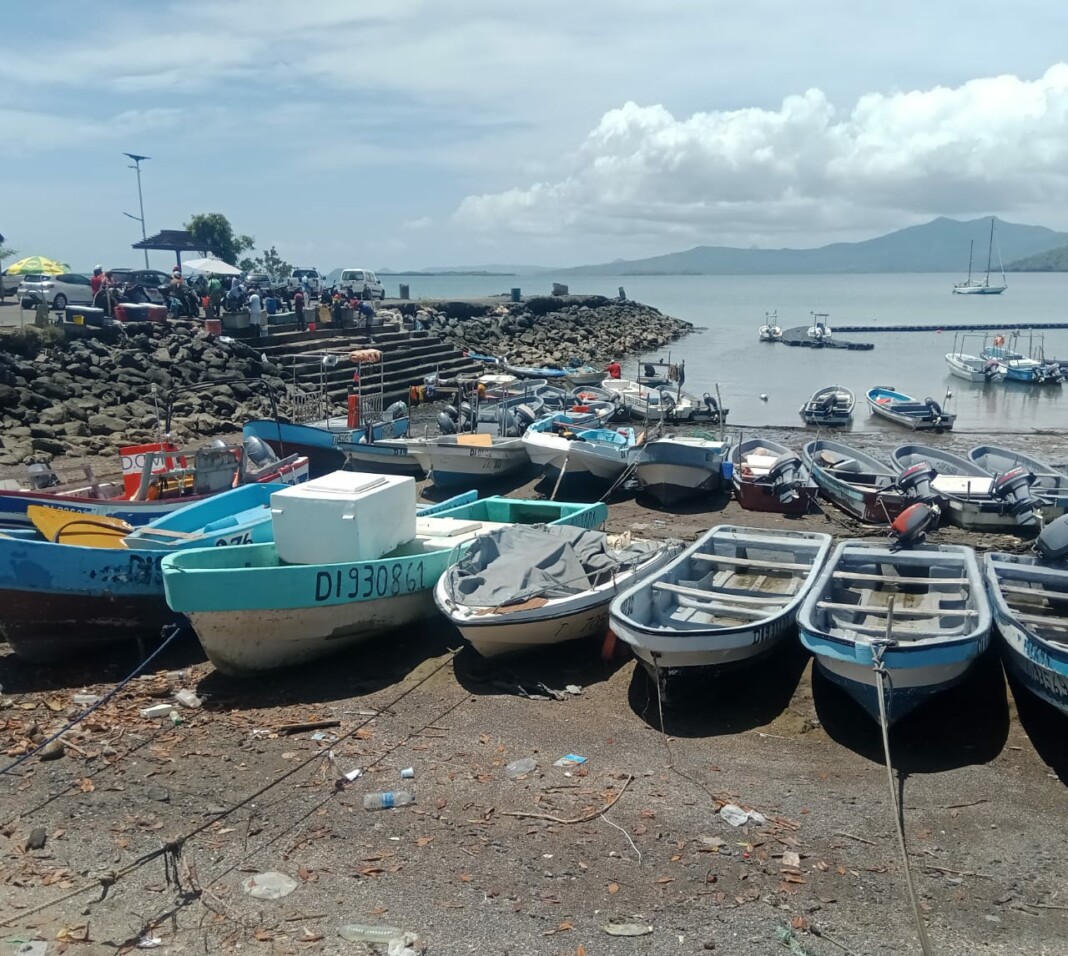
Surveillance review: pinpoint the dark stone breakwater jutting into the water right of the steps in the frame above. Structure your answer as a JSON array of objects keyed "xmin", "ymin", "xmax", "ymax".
[{"xmin": 406, "ymin": 296, "xmax": 694, "ymax": 365}]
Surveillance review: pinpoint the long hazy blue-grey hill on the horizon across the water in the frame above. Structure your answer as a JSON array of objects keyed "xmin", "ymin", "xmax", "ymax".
[{"xmin": 553, "ymin": 217, "xmax": 1068, "ymax": 276}]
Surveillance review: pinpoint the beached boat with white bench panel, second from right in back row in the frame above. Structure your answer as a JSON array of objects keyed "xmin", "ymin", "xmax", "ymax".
[{"xmin": 891, "ymin": 444, "xmax": 1048, "ymax": 534}]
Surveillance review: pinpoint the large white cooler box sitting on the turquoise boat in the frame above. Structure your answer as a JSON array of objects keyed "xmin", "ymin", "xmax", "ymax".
[{"xmin": 270, "ymin": 471, "xmax": 415, "ymax": 564}]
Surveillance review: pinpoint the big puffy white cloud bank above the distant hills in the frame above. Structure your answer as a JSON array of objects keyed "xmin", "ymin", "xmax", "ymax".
[{"xmin": 455, "ymin": 63, "xmax": 1068, "ymax": 241}]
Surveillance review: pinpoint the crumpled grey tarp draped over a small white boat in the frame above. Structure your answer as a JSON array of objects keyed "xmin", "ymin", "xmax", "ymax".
[{"xmin": 445, "ymin": 524, "xmax": 622, "ymax": 608}]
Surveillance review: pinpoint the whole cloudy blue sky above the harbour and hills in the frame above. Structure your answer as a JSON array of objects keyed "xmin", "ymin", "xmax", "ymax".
[{"xmin": 0, "ymin": 0, "xmax": 1068, "ymax": 270}]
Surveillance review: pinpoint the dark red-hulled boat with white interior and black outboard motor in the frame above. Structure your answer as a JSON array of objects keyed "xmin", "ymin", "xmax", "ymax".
[{"xmin": 731, "ymin": 438, "xmax": 819, "ymax": 515}]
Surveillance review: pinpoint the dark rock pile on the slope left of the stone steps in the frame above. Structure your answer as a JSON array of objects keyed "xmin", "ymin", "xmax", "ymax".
[{"xmin": 0, "ymin": 322, "xmax": 285, "ymax": 465}]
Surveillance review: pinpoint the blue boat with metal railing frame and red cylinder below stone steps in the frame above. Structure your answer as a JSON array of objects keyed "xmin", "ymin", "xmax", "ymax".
[{"xmin": 241, "ymin": 348, "xmax": 409, "ymax": 479}]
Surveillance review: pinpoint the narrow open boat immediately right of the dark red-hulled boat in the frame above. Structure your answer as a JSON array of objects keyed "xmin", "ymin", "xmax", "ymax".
[{"xmin": 801, "ymin": 438, "xmax": 913, "ymax": 524}]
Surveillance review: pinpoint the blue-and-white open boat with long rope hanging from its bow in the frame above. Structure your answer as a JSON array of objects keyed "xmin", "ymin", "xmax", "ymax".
[{"xmin": 798, "ymin": 540, "xmax": 991, "ymax": 723}]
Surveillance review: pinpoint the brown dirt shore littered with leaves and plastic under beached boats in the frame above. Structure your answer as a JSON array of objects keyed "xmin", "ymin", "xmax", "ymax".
[{"xmin": 0, "ymin": 433, "xmax": 1068, "ymax": 956}]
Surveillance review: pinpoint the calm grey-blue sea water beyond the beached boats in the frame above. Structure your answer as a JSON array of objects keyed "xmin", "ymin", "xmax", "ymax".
[{"xmin": 387, "ymin": 273, "xmax": 1068, "ymax": 432}]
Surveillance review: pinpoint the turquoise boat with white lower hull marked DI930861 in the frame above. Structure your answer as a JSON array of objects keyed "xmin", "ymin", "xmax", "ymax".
[{"xmin": 162, "ymin": 498, "xmax": 608, "ymax": 675}]
